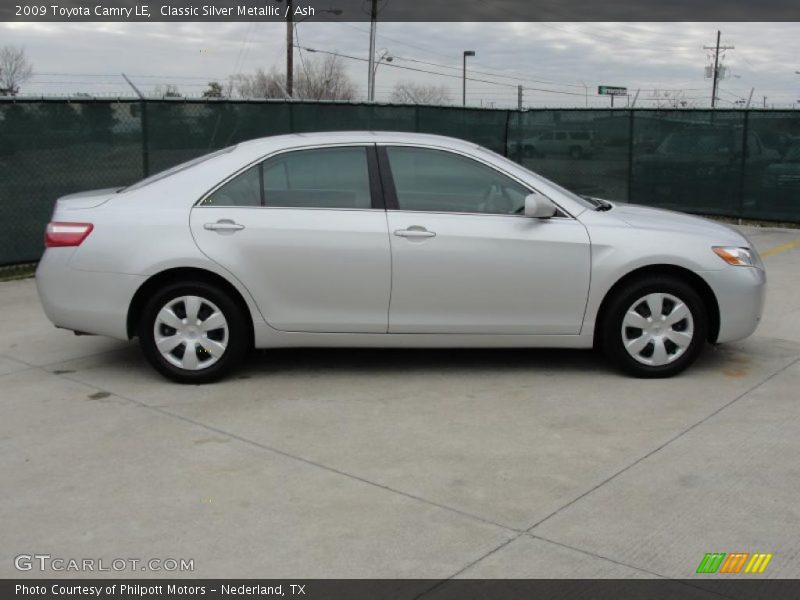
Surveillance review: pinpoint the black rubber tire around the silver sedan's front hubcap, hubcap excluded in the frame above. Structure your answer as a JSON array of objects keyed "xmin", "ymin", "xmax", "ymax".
[{"xmin": 598, "ymin": 276, "xmax": 708, "ymax": 378}]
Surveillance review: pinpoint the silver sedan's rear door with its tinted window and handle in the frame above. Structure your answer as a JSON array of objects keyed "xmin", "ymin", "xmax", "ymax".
[{"xmin": 191, "ymin": 145, "xmax": 391, "ymax": 333}]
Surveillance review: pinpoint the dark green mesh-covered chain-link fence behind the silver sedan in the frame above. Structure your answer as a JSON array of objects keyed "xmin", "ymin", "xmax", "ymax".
[{"xmin": 0, "ymin": 99, "xmax": 800, "ymax": 265}]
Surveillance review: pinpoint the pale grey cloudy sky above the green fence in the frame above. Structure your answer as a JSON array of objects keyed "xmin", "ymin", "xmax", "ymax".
[{"xmin": 0, "ymin": 23, "xmax": 800, "ymax": 107}]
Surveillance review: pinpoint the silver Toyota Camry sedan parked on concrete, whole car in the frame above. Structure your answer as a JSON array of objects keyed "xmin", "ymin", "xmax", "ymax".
[{"xmin": 36, "ymin": 132, "xmax": 766, "ymax": 383}]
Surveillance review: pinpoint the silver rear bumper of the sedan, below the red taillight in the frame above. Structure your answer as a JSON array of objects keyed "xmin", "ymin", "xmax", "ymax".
[{"xmin": 36, "ymin": 248, "xmax": 145, "ymax": 340}]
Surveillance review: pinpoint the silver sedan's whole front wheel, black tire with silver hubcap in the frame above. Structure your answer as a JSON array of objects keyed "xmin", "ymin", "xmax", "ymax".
[{"xmin": 601, "ymin": 277, "xmax": 708, "ymax": 377}]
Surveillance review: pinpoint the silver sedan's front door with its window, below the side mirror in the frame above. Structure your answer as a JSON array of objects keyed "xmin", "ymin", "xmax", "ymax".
[{"xmin": 382, "ymin": 146, "xmax": 590, "ymax": 335}]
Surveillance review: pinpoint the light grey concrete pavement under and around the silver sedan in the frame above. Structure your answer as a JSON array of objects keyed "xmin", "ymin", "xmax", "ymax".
[{"xmin": 0, "ymin": 228, "xmax": 800, "ymax": 578}]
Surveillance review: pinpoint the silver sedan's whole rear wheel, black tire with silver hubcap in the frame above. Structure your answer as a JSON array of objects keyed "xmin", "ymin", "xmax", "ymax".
[{"xmin": 138, "ymin": 281, "xmax": 249, "ymax": 383}]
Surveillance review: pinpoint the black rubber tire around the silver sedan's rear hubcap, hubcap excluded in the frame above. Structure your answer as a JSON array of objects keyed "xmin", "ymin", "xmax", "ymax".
[{"xmin": 138, "ymin": 281, "xmax": 251, "ymax": 384}]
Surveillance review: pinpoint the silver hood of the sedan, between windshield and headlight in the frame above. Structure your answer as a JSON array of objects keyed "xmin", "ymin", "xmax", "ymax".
[{"xmin": 611, "ymin": 202, "xmax": 750, "ymax": 246}]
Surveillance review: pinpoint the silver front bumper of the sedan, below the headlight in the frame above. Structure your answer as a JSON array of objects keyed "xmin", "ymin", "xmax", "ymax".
[{"xmin": 701, "ymin": 267, "xmax": 767, "ymax": 343}]
